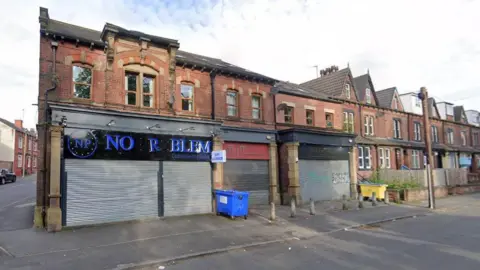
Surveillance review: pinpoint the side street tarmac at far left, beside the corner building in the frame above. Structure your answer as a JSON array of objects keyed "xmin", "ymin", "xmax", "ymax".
[{"xmin": 0, "ymin": 175, "xmax": 36, "ymax": 231}]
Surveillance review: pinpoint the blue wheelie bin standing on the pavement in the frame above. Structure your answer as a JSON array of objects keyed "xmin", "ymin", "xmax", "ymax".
[{"xmin": 215, "ymin": 190, "xmax": 248, "ymax": 219}]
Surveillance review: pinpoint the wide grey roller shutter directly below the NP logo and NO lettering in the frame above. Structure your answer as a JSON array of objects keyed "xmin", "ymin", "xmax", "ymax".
[{"xmin": 65, "ymin": 159, "xmax": 160, "ymax": 226}]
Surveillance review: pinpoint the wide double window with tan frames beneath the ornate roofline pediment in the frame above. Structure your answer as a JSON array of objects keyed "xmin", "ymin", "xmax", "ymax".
[{"xmin": 125, "ymin": 72, "xmax": 155, "ymax": 108}]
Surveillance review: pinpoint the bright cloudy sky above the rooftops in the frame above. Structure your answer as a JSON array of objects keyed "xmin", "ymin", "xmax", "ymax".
[{"xmin": 0, "ymin": 0, "xmax": 480, "ymax": 128}]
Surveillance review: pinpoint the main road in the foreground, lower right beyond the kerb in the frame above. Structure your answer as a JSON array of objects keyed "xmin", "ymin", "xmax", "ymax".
[{"xmin": 142, "ymin": 195, "xmax": 480, "ymax": 270}]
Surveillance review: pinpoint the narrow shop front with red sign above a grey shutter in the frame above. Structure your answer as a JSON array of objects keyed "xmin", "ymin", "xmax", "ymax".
[{"xmin": 222, "ymin": 127, "xmax": 278, "ymax": 205}]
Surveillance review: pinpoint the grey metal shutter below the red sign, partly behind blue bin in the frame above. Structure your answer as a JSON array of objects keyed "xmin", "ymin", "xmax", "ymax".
[{"xmin": 223, "ymin": 160, "xmax": 269, "ymax": 205}]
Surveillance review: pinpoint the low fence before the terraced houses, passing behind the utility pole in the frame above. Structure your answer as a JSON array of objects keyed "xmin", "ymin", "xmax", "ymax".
[{"xmin": 378, "ymin": 169, "xmax": 468, "ymax": 187}]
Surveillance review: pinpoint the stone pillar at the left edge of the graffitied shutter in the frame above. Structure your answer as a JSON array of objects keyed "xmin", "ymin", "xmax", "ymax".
[{"xmin": 285, "ymin": 142, "xmax": 302, "ymax": 205}]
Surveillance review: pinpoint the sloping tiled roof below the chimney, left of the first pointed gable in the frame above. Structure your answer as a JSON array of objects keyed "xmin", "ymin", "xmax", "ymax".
[{"xmin": 300, "ymin": 67, "xmax": 351, "ymax": 97}]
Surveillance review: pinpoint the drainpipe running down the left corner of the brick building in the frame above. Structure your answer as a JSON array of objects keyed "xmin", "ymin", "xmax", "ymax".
[{"xmin": 42, "ymin": 41, "xmax": 58, "ymax": 228}]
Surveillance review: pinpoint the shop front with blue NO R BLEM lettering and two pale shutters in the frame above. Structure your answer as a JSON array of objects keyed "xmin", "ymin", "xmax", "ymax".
[{"xmin": 48, "ymin": 106, "xmax": 221, "ymax": 226}]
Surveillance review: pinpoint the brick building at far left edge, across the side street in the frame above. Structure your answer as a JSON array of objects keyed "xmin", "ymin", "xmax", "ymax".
[{"xmin": 0, "ymin": 118, "xmax": 38, "ymax": 176}]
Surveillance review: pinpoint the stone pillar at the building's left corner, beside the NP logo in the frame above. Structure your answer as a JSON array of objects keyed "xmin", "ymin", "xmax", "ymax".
[{"xmin": 47, "ymin": 126, "xmax": 63, "ymax": 232}]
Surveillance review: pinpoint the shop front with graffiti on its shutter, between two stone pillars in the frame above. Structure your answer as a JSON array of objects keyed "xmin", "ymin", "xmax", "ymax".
[{"xmin": 278, "ymin": 129, "xmax": 356, "ymax": 203}]
